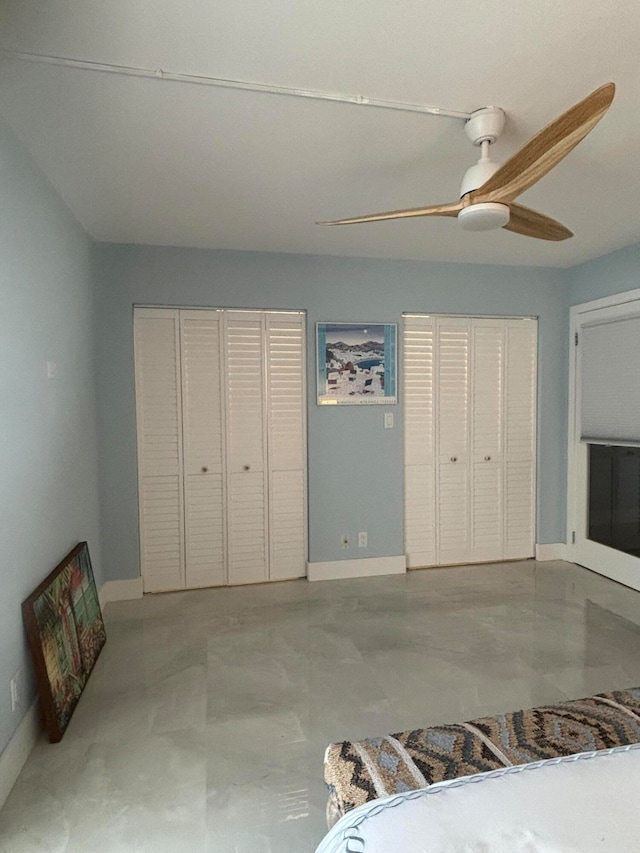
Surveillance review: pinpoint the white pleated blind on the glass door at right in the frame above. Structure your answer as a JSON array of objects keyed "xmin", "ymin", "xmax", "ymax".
[{"xmin": 580, "ymin": 316, "xmax": 640, "ymax": 443}]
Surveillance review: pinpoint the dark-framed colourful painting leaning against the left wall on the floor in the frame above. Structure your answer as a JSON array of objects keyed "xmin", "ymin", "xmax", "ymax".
[{"xmin": 22, "ymin": 542, "xmax": 107, "ymax": 743}]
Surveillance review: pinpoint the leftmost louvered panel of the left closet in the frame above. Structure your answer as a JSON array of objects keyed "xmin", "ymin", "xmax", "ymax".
[{"xmin": 134, "ymin": 308, "xmax": 184, "ymax": 592}]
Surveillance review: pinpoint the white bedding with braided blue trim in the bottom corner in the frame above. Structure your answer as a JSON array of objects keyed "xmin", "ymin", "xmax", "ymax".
[{"xmin": 316, "ymin": 744, "xmax": 640, "ymax": 853}]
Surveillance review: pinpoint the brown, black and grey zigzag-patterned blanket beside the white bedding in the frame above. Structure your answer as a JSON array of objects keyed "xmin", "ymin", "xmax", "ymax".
[{"xmin": 324, "ymin": 687, "xmax": 640, "ymax": 827}]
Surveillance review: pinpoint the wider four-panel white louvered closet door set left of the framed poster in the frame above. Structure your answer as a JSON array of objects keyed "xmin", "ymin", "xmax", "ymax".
[{"xmin": 134, "ymin": 308, "xmax": 306, "ymax": 592}]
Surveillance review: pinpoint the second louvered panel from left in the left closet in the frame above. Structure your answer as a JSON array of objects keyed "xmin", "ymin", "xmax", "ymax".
[{"xmin": 180, "ymin": 310, "xmax": 226, "ymax": 588}]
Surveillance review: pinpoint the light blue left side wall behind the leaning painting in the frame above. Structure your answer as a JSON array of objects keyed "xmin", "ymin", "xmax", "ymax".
[{"xmin": 0, "ymin": 120, "xmax": 100, "ymax": 752}]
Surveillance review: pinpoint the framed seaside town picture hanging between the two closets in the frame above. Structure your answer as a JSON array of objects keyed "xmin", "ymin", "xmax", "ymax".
[{"xmin": 316, "ymin": 323, "xmax": 397, "ymax": 406}]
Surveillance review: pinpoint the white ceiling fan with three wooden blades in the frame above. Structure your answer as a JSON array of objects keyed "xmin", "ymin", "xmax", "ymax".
[{"xmin": 316, "ymin": 83, "xmax": 616, "ymax": 240}]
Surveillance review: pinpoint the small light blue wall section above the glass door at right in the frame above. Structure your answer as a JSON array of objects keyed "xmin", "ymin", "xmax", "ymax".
[{"xmin": 565, "ymin": 243, "xmax": 640, "ymax": 308}]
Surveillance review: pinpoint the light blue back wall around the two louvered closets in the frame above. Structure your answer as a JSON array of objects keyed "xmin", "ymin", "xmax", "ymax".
[{"xmin": 93, "ymin": 245, "xmax": 567, "ymax": 579}]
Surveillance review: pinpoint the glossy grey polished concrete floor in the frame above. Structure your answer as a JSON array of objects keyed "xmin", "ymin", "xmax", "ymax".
[{"xmin": 0, "ymin": 561, "xmax": 640, "ymax": 853}]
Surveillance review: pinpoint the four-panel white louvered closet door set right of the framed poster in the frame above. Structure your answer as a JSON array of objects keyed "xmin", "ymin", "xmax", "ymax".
[{"xmin": 403, "ymin": 315, "xmax": 537, "ymax": 567}]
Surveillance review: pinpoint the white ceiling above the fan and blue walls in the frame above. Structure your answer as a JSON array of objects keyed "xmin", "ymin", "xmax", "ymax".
[{"xmin": 0, "ymin": 0, "xmax": 640, "ymax": 267}]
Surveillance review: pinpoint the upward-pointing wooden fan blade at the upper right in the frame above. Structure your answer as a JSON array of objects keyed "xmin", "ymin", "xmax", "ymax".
[{"xmin": 470, "ymin": 83, "xmax": 616, "ymax": 204}]
